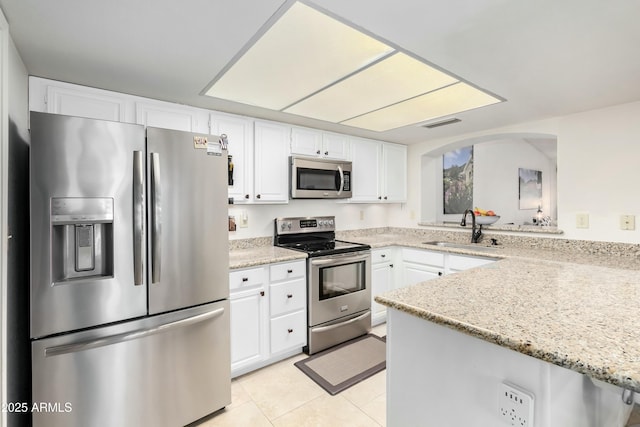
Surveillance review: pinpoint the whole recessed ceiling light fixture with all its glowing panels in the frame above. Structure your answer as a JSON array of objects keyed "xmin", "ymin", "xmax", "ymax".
[{"xmin": 204, "ymin": 0, "xmax": 503, "ymax": 132}]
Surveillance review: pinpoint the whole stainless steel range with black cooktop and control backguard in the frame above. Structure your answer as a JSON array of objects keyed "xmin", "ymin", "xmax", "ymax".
[{"xmin": 274, "ymin": 216, "xmax": 371, "ymax": 354}]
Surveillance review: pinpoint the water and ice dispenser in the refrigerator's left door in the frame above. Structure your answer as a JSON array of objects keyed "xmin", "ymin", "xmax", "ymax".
[{"xmin": 51, "ymin": 197, "xmax": 113, "ymax": 283}]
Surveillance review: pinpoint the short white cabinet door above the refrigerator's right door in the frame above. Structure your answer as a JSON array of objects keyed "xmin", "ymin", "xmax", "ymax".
[{"xmin": 136, "ymin": 100, "xmax": 210, "ymax": 133}]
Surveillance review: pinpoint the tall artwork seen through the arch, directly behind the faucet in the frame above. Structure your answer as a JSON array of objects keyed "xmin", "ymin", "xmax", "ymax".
[{"xmin": 442, "ymin": 146, "xmax": 473, "ymax": 214}]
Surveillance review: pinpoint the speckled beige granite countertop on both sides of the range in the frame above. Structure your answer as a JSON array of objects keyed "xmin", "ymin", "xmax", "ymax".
[{"xmin": 230, "ymin": 229, "xmax": 640, "ymax": 392}]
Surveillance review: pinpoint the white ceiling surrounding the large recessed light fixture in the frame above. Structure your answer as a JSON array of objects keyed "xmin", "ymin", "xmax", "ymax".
[{"xmin": 0, "ymin": 0, "xmax": 640, "ymax": 144}]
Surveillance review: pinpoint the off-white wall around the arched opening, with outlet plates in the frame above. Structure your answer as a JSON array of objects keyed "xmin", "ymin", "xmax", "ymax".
[{"xmin": 402, "ymin": 102, "xmax": 640, "ymax": 243}]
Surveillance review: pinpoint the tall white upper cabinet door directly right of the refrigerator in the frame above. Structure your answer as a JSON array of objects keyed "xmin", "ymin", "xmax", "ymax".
[{"xmin": 211, "ymin": 113, "xmax": 253, "ymax": 203}]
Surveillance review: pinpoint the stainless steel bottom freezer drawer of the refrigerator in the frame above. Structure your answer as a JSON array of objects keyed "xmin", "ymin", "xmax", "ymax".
[{"xmin": 32, "ymin": 300, "xmax": 231, "ymax": 427}]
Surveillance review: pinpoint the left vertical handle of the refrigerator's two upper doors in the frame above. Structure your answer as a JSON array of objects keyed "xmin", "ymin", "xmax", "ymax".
[{"xmin": 133, "ymin": 151, "xmax": 144, "ymax": 286}]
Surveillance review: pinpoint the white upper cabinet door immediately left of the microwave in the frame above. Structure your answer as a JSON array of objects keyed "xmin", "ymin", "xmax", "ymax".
[{"xmin": 253, "ymin": 121, "xmax": 291, "ymax": 203}]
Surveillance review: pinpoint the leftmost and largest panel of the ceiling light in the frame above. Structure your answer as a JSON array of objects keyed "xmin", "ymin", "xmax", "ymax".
[{"xmin": 206, "ymin": 3, "xmax": 393, "ymax": 110}]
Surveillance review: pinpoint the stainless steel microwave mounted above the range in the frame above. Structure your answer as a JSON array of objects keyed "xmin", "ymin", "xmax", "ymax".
[{"xmin": 290, "ymin": 156, "xmax": 351, "ymax": 199}]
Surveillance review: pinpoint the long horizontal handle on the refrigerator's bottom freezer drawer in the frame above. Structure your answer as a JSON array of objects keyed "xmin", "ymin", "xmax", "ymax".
[{"xmin": 44, "ymin": 307, "xmax": 224, "ymax": 357}]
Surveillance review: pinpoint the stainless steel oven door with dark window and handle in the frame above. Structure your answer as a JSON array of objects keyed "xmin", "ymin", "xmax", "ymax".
[{"xmin": 309, "ymin": 251, "xmax": 371, "ymax": 326}]
